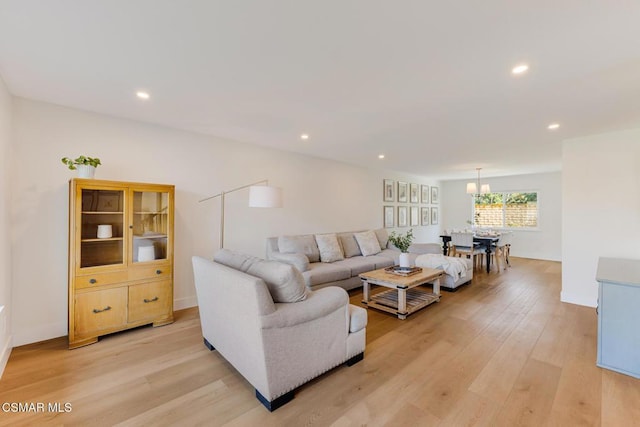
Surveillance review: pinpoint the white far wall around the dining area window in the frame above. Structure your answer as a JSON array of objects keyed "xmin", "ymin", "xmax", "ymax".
[{"xmin": 441, "ymin": 172, "xmax": 562, "ymax": 261}]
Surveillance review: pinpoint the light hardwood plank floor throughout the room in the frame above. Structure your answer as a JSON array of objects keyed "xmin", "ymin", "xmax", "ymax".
[{"xmin": 0, "ymin": 258, "xmax": 640, "ymax": 426}]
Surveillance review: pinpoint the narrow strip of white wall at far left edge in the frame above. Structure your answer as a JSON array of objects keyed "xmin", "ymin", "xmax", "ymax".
[{"xmin": 0, "ymin": 77, "xmax": 12, "ymax": 376}]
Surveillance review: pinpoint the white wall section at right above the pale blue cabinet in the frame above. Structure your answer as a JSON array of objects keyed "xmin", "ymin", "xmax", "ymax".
[{"xmin": 561, "ymin": 129, "xmax": 640, "ymax": 307}]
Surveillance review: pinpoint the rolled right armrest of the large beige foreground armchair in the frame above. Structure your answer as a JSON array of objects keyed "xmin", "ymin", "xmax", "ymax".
[{"xmin": 260, "ymin": 286, "xmax": 349, "ymax": 329}]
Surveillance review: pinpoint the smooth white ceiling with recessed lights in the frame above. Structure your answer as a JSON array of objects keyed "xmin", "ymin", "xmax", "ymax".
[{"xmin": 0, "ymin": 0, "xmax": 640, "ymax": 179}]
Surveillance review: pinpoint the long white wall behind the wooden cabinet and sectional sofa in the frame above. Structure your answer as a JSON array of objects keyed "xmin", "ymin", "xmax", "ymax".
[{"xmin": 11, "ymin": 98, "xmax": 439, "ymax": 345}]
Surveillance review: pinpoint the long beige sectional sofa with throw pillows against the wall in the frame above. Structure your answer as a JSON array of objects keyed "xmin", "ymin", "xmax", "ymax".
[{"xmin": 266, "ymin": 229, "xmax": 473, "ymax": 290}]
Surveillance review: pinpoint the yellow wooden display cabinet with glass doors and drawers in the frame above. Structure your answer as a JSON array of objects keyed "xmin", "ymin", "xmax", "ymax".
[{"xmin": 69, "ymin": 179, "xmax": 174, "ymax": 348}]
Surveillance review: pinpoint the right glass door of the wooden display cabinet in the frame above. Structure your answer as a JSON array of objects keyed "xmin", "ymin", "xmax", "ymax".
[{"xmin": 132, "ymin": 191, "xmax": 169, "ymax": 263}]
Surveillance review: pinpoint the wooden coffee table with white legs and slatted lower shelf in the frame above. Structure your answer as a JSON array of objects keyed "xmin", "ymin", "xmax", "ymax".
[{"xmin": 360, "ymin": 268, "xmax": 444, "ymax": 320}]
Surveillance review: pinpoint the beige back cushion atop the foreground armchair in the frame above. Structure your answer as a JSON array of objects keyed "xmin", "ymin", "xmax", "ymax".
[{"xmin": 213, "ymin": 249, "xmax": 308, "ymax": 302}]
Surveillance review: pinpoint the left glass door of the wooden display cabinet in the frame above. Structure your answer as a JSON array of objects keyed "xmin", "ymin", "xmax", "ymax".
[{"xmin": 80, "ymin": 189, "xmax": 124, "ymax": 268}]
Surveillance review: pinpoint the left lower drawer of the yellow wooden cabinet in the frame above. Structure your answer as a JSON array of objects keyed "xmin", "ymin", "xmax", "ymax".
[{"xmin": 75, "ymin": 287, "xmax": 127, "ymax": 336}]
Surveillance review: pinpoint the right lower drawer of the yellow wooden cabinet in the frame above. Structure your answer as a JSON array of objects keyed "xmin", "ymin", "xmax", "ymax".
[{"xmin": 129, "ymin": 280, "xmax": 173, "ymax": 322}]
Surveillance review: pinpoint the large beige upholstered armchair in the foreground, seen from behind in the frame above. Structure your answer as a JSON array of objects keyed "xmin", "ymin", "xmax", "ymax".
[{"xmin": 193, "ymin": 251, "xmax": 367, "ymax": 411}]
